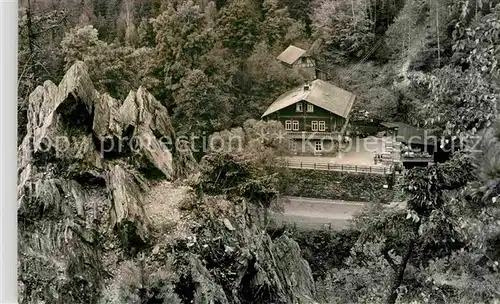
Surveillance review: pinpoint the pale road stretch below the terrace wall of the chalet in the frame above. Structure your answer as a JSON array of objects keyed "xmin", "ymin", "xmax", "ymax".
[{"xmin": 275, "ymin": 196, "xmax": 404, "ymax": 230}]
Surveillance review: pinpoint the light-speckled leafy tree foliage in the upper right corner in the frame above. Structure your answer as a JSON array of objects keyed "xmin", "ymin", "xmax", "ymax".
[{"xmin": 414, "ymin": 6, "xmax": 500, "ymax": 137}]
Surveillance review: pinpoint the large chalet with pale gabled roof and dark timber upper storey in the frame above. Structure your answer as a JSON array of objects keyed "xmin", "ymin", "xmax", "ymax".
[{"xmin": 262, "ymin": 79, "xmax": 356, "ymax": 155}]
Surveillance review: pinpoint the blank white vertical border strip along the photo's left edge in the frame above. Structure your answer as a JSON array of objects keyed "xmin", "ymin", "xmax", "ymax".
[{"xmin": 0, "ymin": 0, "xmax": 18, "ymax": 304}]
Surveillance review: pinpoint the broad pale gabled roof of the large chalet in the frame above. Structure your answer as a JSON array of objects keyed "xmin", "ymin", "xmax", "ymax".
[{"xmin": 262, "ymin": 79, "xmax": 356, "ymax": 118}]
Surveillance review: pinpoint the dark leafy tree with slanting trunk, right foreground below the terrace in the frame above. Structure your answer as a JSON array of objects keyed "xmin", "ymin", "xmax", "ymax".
[{"xmin": 320, "ymin": 155, "xmax": 475, "ymax": 303}]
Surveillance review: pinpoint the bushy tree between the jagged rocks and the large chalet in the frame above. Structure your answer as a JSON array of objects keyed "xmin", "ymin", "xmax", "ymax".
[{"xmin": 197, "ymin": 120, "xmax": 286, "ymax": 208}]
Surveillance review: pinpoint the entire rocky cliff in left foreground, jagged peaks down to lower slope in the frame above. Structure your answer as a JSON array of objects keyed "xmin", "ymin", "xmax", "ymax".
[{"xmin": 18, "ymin": 62, "xmax": 314, "ymax": 304}]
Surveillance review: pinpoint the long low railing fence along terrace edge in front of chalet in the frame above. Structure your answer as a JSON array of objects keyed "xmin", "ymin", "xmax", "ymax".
[{"xmin": 286, "ymin": 160, "xmax": 392, "ymax": 174}]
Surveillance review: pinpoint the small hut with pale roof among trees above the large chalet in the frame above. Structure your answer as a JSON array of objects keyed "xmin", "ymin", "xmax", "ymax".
[{"xmin": 276, "ymin": 45, "xmax": 317, "ymax": 80}]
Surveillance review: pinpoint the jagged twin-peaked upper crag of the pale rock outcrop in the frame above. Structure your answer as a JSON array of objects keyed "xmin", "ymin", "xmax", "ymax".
[{"xmin": 20, "ymin": 62, "xmax": 175, "ymax": 179}]
